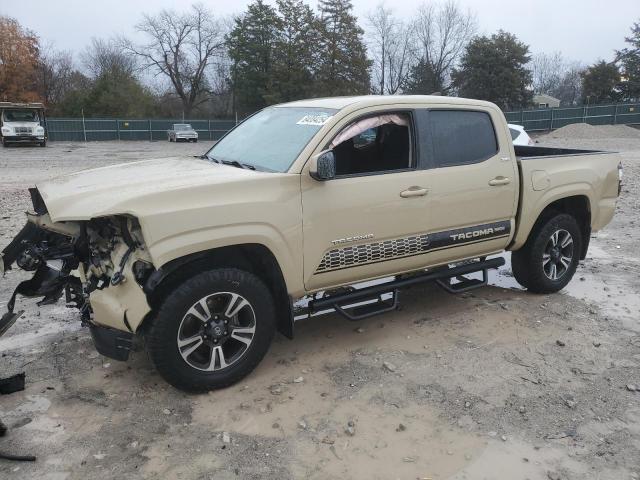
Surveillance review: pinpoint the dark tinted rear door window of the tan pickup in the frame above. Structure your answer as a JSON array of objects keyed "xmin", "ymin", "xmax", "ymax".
[{"xmin": 429, "ymin": 110, "xmax": 498, "ymax": 167}]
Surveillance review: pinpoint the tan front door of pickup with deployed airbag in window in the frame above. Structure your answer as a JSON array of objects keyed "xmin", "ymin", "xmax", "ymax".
[{"xmin": 301, "ymin": 106, "xmax": 430, "ymax": 290}]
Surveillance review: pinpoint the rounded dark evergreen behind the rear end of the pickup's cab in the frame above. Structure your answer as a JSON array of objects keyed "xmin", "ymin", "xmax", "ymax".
[{"xmin": 452, "ymin": 30, "xmax": 533, "ymax": 110}]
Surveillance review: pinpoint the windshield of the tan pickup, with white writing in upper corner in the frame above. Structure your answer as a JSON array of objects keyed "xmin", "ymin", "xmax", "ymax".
[{"xmin": 207, "ymin": 107, "xmax": 336, "ymax": 172}]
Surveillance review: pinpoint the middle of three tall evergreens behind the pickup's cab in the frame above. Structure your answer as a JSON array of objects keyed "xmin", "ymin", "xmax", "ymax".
[{"xmin": 271, "ymin": 0, "xmax": 318, "ymax": 103}]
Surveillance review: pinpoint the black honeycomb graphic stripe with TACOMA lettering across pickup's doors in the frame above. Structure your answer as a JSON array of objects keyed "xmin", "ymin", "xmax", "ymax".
[{"xmin": 316, "ymin": 220, "xmax": 511, "ymax": 273}]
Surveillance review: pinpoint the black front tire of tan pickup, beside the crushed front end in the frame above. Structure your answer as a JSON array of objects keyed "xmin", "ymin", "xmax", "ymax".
[{"xmin": 145, "ymin": 268, "xmax": 276, "ymax": 392}]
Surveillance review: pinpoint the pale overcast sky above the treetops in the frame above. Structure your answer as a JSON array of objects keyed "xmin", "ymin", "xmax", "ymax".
[{"xmin": 0, "ymin": 0, "xmax": 640, "ymax": 65}]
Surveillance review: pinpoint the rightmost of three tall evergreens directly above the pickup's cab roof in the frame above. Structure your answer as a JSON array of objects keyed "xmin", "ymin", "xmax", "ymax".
[{"xmin": 316, "ymin": 0, "xmax": 371, "ymax": 96}]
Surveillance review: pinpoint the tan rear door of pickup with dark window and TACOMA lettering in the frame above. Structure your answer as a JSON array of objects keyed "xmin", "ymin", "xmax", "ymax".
[{"xmin": 416, "ymin": 106, "xmax": 519, "ymax": 264}]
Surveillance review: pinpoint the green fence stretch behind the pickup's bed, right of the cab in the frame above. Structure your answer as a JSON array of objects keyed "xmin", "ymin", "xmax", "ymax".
[{"xmin": 504, "ymin": 103, "xmax": 640, "ymax": 131}]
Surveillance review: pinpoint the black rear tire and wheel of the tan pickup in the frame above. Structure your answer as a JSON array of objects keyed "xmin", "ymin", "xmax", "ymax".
[{"xmin": 511, "ymin": 213, "xmax": 582, "ymax": 293}]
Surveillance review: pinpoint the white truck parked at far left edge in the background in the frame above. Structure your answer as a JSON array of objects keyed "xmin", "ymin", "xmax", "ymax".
[{"xmin": 0, "ymin": 102, "xmax": 47, "ymax": 147}]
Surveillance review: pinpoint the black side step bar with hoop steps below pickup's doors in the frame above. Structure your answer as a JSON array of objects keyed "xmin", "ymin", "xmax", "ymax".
[{"xmin": 307, "ymin": 257, "xmax": 505, "ymax": 320}]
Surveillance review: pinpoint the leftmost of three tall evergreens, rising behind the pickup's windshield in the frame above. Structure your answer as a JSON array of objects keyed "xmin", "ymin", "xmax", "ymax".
[{"xmin": 227, "ymin": 0, "xmax": 281, "ymax": 114}]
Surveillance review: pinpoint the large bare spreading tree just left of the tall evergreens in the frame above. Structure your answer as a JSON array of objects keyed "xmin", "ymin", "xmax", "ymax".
[{"xmin": 121, "ymin": 4, "xmax": 225, "ymax": 114}]
